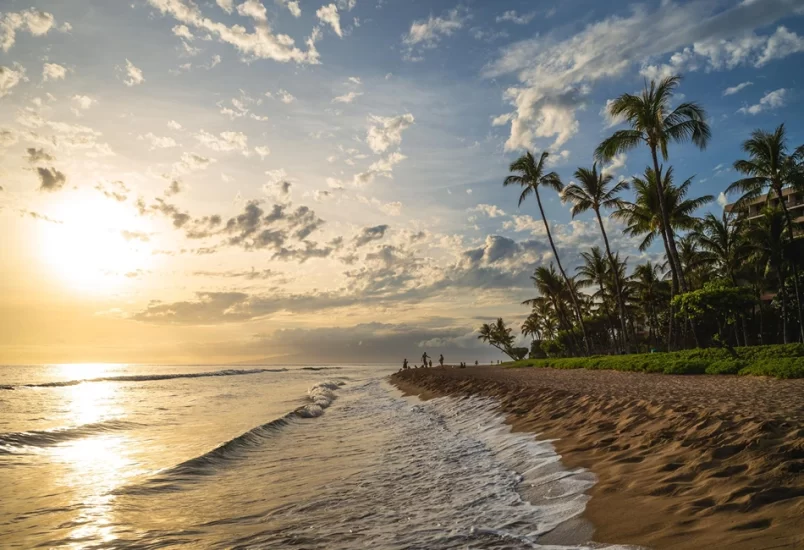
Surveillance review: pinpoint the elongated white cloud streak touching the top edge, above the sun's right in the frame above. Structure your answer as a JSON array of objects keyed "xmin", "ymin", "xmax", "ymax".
[{"xmin": 148, "ymin": 0, "xmax": 318, "ymax": 63}]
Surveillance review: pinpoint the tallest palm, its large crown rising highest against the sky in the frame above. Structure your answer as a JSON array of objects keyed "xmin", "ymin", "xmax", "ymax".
[{"xmin": 595, "ymin": 76, "xmax": 711, "ymax": 298}]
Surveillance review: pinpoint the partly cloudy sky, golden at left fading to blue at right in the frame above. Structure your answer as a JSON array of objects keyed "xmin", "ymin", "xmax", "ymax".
[{"xmin": 0, "ymin": 0, "xmax": 804, "ymax": 364}]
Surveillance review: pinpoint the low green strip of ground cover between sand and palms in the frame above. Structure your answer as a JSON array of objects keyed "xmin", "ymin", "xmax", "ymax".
[{"xmin": 505, "ymin": 344, "xmax": 804, "ymax": 378}]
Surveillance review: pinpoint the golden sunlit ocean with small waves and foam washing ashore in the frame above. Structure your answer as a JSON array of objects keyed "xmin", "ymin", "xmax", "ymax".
[{"xmin": 0, "ymin": 365, "xmax": 636, "ymax": 550}]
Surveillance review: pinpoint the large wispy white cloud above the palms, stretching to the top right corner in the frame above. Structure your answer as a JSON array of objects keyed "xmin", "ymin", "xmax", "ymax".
[{"xmin": 483, "ymin": 0, "xmax": 795, "ymax": 150}]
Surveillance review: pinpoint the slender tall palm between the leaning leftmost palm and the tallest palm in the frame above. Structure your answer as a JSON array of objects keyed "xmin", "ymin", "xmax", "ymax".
[{"xmin": 561, "ymin": 163, "xmax": 628, "ymax": 352}]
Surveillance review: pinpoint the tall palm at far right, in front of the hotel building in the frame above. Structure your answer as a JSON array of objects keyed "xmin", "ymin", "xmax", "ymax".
[{"xmin": 726, "ymin": 124, "xmax": 804, "ymax": 342}]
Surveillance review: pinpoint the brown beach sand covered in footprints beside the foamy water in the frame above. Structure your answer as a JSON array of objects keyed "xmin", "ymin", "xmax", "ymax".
[{"xmin": 391, "ymin": 367, "xmax": 804, "ymax": 550}]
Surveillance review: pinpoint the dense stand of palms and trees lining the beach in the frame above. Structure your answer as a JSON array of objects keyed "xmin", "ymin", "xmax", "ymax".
[{"xmin": 479, "ymin": 76, "xmax": 804, "ymax": 359}]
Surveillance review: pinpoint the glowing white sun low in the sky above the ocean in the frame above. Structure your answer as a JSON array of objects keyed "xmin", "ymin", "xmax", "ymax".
[{"xmin": 38, "ymin": 193, "xmax": 152, "ymax": 293}]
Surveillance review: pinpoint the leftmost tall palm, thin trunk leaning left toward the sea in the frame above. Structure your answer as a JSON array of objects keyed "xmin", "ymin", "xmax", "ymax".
[{"xmin": 503, "ymin": 151, "xmax": 589, "ymax": 354}]
